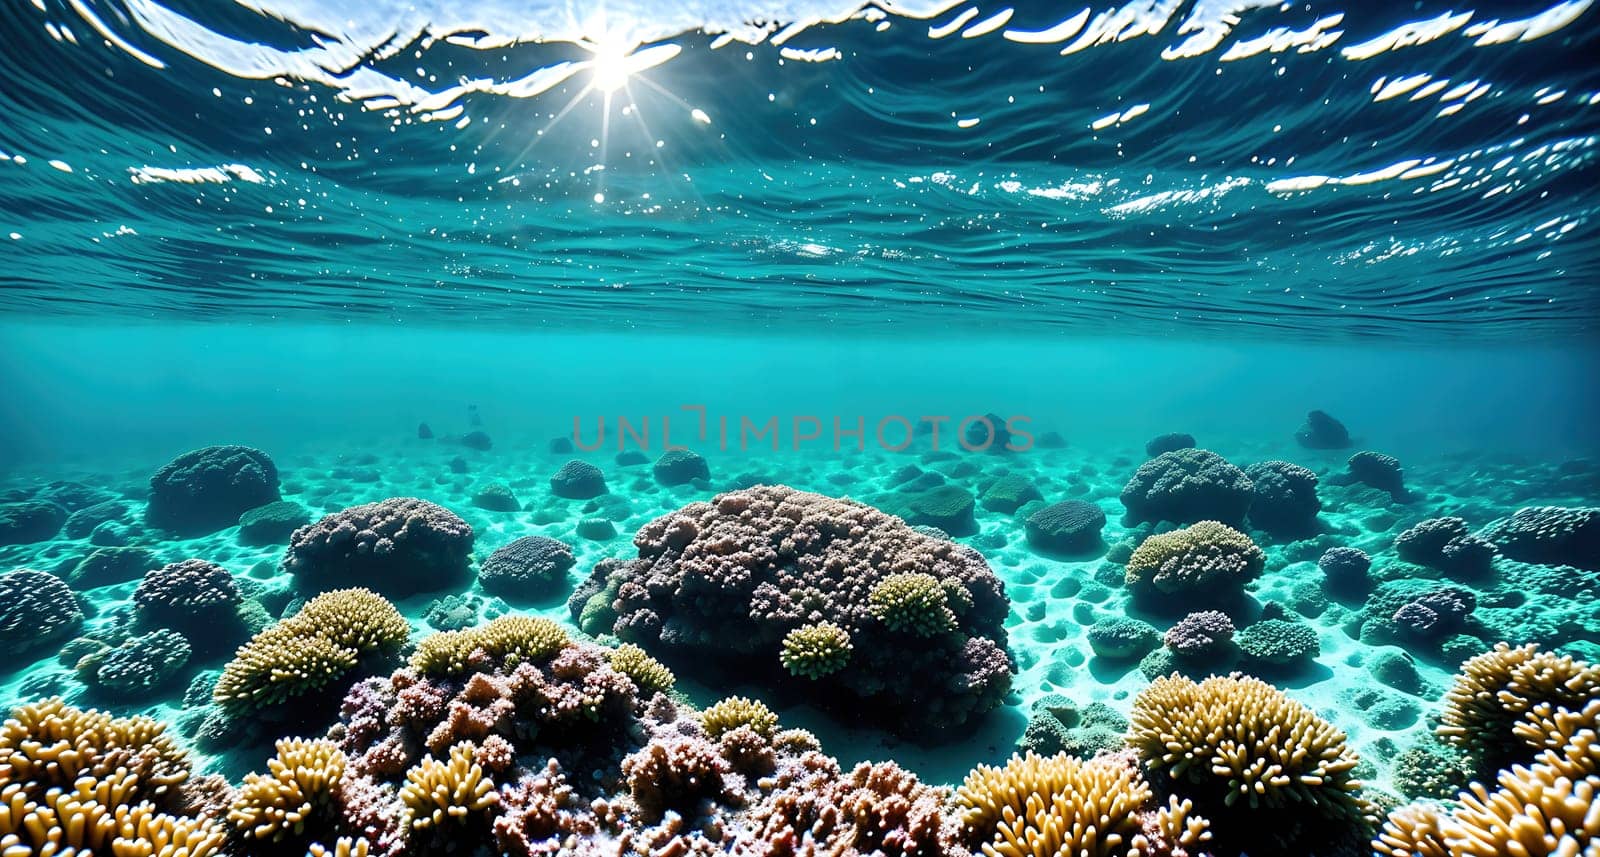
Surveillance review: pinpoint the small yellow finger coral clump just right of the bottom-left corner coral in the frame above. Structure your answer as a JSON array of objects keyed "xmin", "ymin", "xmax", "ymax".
[{"xmin": 227, "ymin": 739, "xmax": 346, "ymax": 841}]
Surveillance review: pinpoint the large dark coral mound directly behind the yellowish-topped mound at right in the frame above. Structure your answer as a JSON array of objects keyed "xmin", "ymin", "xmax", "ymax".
[{"xmin": 1122, "ymin": 449, "xmax": 1256, "ymax": 526}]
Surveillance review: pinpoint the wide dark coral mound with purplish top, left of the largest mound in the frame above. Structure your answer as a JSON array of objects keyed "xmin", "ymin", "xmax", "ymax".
[{"xmin": 283, "ymin": 497, "xmax": 472, "ymax": 596}]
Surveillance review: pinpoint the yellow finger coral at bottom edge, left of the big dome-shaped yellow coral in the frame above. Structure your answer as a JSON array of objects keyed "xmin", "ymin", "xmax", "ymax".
[{"xmin": 955, "ymin": 751, "xmax": 1211, "ymax": 857}]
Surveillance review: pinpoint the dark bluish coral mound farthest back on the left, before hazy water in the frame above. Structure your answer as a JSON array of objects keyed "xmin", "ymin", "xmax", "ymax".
[{"xmin": 144, "ymin": 446, "xmax": 280, "ymax": 536}]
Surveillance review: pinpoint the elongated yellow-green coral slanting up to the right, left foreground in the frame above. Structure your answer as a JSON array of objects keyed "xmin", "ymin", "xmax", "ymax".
[{"xmin": 213, "ymin": 588, "xmax": 411, "ymax": 713}]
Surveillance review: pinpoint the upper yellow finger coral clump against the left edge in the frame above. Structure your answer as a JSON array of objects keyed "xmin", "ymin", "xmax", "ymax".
[{"xmin": 0, "ymin": 697, "xmax": 189, "ymax": 798}]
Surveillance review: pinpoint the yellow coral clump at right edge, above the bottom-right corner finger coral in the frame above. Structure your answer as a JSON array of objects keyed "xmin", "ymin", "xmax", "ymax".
[{"xmin": 1438, "ymin": 643, "xmax": 1600, "ymax": 772}]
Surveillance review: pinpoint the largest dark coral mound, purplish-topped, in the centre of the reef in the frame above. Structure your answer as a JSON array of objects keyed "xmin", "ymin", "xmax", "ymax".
[{"xmin": 568, "ymin": 486, "xmax": 1013, "ymax": 732}]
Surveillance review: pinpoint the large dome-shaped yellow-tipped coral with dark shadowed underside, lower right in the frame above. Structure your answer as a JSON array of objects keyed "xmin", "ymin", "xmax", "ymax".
[{"xmin": 1128, "ymin": 673, "xmax": 1376, "ymax": 854}]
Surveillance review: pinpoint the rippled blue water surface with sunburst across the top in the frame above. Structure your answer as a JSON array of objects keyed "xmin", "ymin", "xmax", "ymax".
[{"xmin": 0, "ymin": 0, "xmax": 1600, "ymax": 334}]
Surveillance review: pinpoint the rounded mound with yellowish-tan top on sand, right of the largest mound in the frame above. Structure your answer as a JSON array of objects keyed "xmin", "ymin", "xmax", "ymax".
[{"xmin": 1125, "ymin": 521, "xmax": 1267, "ymax": 601}]
